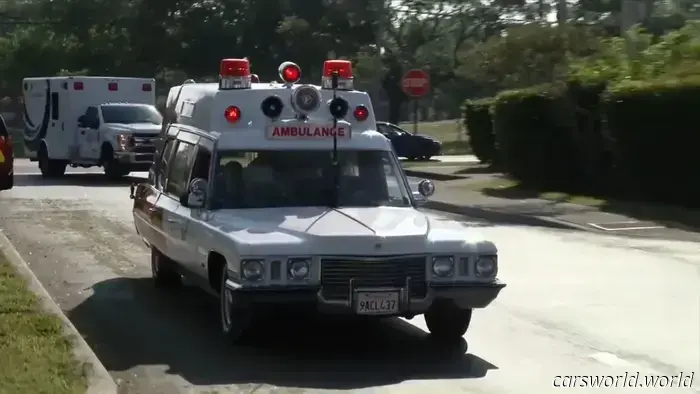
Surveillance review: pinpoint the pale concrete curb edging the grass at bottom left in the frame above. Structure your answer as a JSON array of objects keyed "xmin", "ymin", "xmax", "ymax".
[{"xmin": 0, "ymin": 230, "xmax": 117, "ymax": 394}]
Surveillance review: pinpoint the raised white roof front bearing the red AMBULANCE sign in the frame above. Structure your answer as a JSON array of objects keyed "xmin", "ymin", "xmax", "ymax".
[{"xmin": 168, "ymin": 64, "xmax": 392, "ymax": 150}]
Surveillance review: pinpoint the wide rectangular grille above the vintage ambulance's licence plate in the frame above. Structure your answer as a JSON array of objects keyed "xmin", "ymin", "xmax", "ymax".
[{"xmin": 321, "ymin": 256, "xmax": 427, "ymax": 300}]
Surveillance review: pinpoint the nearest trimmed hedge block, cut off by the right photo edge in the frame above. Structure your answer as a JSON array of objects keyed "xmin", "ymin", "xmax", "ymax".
[{"xmin": 604, "ymin": 77, "xmax": 700, "ymax": 206}]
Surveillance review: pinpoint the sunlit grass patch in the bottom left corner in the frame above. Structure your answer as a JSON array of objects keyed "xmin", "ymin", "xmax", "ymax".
[{"xmin": 0, "ymin": 251, "xmax": 87, "ymax": 394}]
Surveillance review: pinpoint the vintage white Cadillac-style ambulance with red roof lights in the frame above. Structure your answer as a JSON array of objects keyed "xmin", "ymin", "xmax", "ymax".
[{"xmin": 131, "ymin": 59, "xmax": 505, "ymax": 340}]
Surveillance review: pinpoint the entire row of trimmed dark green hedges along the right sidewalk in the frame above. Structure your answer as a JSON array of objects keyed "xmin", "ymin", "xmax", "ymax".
[{"xmin": 464, "ymin": 77, "xmax": 700, "ymax": 207}]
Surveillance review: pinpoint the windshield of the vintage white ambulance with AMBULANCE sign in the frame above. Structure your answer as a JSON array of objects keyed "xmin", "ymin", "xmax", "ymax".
[{"xmin": 212, "ymin": 150, "xmax": 411, "ymax": 209}]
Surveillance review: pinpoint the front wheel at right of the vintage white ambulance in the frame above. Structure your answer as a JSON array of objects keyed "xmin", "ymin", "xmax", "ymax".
[{"xmin": 425, "ymin": 301, "xmax": 472, "ymax": 342}]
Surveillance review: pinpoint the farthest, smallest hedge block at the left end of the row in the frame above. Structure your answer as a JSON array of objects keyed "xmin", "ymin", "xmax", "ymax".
[{"xmin": 463, "ymin": 98, "xmax": 496, "ymax": 163}]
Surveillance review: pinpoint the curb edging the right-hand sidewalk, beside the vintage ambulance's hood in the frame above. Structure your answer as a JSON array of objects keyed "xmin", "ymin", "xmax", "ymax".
[{"xmin": 423, "ymin": 200, "xmax": 593, "ymax": 231}]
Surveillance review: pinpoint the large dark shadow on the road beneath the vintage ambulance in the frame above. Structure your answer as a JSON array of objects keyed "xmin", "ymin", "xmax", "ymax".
[{"xmin": 68, "ymin": 278, "xmax": 496, "ymax": 389}]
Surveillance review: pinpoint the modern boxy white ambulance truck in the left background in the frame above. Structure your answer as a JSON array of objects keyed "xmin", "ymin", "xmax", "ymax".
[{"xmin": 22, "ymin": 76, "xmax": 162, "ymax": 178}]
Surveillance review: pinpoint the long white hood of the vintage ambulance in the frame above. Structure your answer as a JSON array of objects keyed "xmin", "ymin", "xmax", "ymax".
[{"xmin": 209, "ymin": 207, "xmax": 495, "ymax": 256}]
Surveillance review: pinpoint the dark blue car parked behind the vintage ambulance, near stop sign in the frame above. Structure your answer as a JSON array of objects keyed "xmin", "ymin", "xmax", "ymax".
[{"xmin": 377, "ymin": 122, "xmax": 442, "ymax": 160}]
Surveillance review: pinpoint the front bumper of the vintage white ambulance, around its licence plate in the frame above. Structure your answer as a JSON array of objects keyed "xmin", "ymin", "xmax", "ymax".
[{"xmin": 226, "ymin": 276, "xmax": 506, "ymax": 316}]
